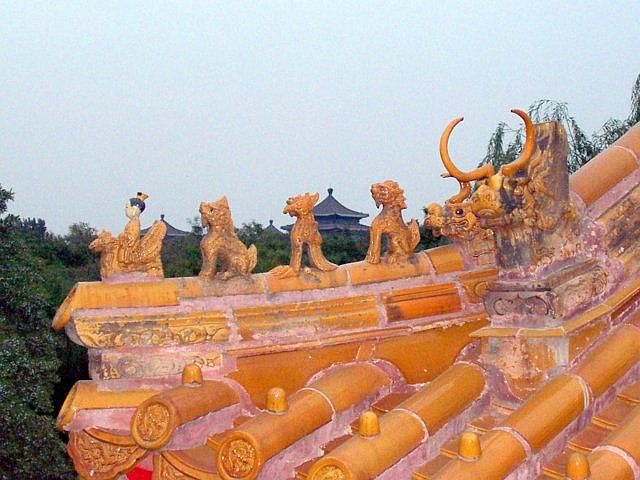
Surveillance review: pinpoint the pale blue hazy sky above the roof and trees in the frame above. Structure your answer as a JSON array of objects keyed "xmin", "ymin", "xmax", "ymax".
[{"xmin": 0, "ymin": 0, "xmax": 640, "ymax": 233}]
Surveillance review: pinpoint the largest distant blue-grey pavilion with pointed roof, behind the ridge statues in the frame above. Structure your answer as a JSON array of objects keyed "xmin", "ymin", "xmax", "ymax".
[{"xmin": 282, "ymin": 188, "xmax": 369, "ymax": 236}]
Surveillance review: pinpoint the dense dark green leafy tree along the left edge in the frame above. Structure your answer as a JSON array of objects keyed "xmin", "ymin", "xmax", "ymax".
[{"xmin": 0, "ymin": 186, "xmax": 73, "ymax": 480}]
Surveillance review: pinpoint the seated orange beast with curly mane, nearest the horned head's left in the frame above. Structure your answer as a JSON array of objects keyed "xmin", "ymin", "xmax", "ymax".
[{"xmin": 365, "ymin": 180, "xmax": 420, "ymax": 264}]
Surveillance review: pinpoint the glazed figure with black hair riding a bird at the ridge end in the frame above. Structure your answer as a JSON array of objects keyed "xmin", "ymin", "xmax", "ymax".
[{"xmin": 89, "ymin": 192, "xmax": 167, "ymax": 279}]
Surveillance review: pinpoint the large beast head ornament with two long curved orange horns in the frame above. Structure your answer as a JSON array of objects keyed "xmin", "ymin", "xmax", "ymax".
[{"xmin": 427, "ymin": 109, "xmax": 582, "ymax": 272}]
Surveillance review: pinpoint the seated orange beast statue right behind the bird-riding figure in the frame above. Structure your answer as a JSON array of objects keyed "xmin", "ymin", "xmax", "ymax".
[{"xmin": 199, "ymin": 197, "xmax": 258, "ymax": 279}]
